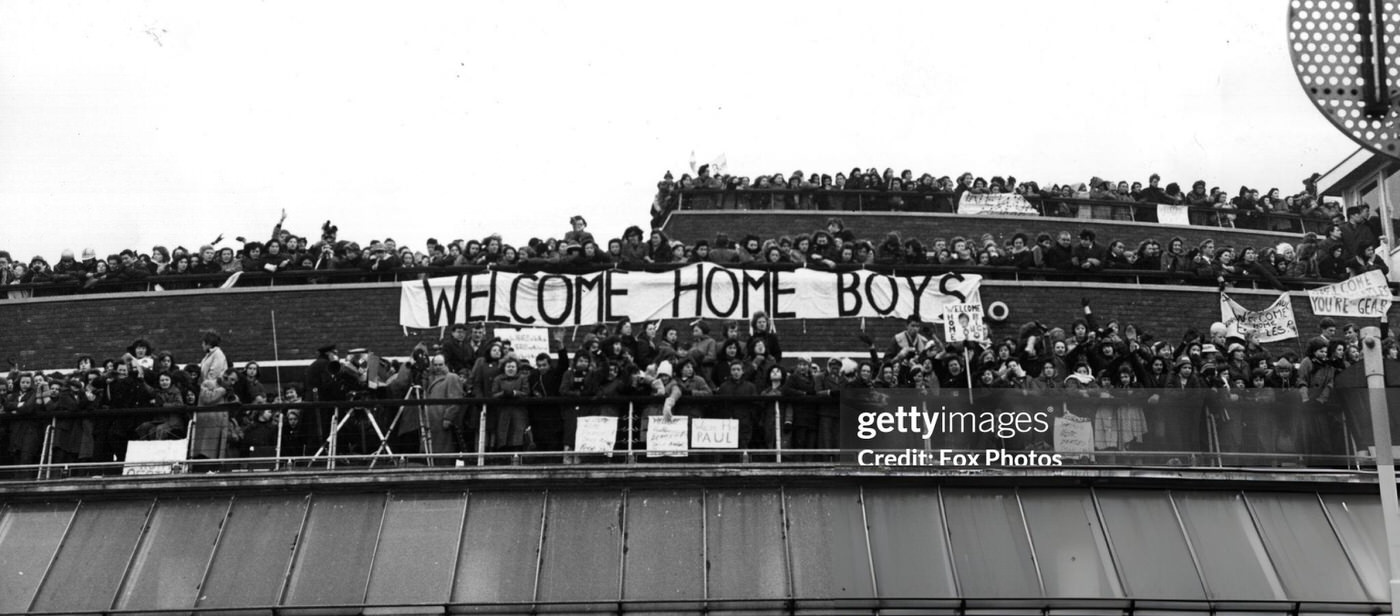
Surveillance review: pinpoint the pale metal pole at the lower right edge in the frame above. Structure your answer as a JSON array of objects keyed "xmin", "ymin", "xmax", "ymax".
[{"xmin": 1361, "ymin": 322, "xmax": 1400, "ymax": 613}]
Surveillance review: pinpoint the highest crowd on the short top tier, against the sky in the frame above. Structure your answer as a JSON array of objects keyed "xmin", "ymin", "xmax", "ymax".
[{"xmin": 652, "ymin": 165, "xmax": 1341, "ymax": 228}]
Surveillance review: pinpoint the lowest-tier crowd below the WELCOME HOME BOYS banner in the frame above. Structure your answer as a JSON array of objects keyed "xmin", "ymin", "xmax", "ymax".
[{"xmin": 0, "ymin": 300, "xmax": 1383, "ymax": 465}]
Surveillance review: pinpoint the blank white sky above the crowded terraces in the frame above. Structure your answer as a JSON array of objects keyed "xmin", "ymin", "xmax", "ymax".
[{"xmin": 0, "ymin": 0, "xmax": 1355, "ymax": 259}]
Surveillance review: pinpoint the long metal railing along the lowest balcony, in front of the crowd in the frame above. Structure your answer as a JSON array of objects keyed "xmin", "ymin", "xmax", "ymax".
[{"xmin": 0, "ymin": 389, "xmax": 1373, "ymax": 480}]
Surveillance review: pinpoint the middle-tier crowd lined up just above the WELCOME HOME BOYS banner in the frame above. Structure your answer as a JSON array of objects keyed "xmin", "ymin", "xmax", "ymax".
[{"xmin": 0, "ymin": 177, "xmax": 1389, "ymax": 297}]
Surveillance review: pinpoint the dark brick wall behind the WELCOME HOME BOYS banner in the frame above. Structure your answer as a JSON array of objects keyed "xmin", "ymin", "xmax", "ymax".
[{"xmin": 0, "ymin": 280, "xmax": 1371, "ymax": 378}]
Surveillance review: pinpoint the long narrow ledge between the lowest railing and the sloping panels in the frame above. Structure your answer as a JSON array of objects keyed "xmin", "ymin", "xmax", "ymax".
[{"xmin": 0, "ymin": 463, "xmax": 1378, "ymax": 500}]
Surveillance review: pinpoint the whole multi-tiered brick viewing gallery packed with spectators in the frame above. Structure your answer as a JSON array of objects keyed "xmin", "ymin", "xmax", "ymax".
[{"xmin": 0, "ymin": 156, "xmax": 1400, "ymax": 615}]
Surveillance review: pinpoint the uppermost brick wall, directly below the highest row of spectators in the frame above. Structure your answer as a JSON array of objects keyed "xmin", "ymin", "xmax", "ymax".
[{"xmin": 665, "ymin": 211, "xmax": 1301, "ymax": 249}]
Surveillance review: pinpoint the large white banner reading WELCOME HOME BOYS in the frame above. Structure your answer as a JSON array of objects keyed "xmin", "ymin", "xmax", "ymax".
[{"xmin": 399, "ymin": 263, "xmax": 981, "ymax": 329}]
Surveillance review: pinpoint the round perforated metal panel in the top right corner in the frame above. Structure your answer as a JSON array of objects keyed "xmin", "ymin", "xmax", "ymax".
[{"xmin": 1288, "ymin": 0, "xmax": 1400, "ymax": 157}]
